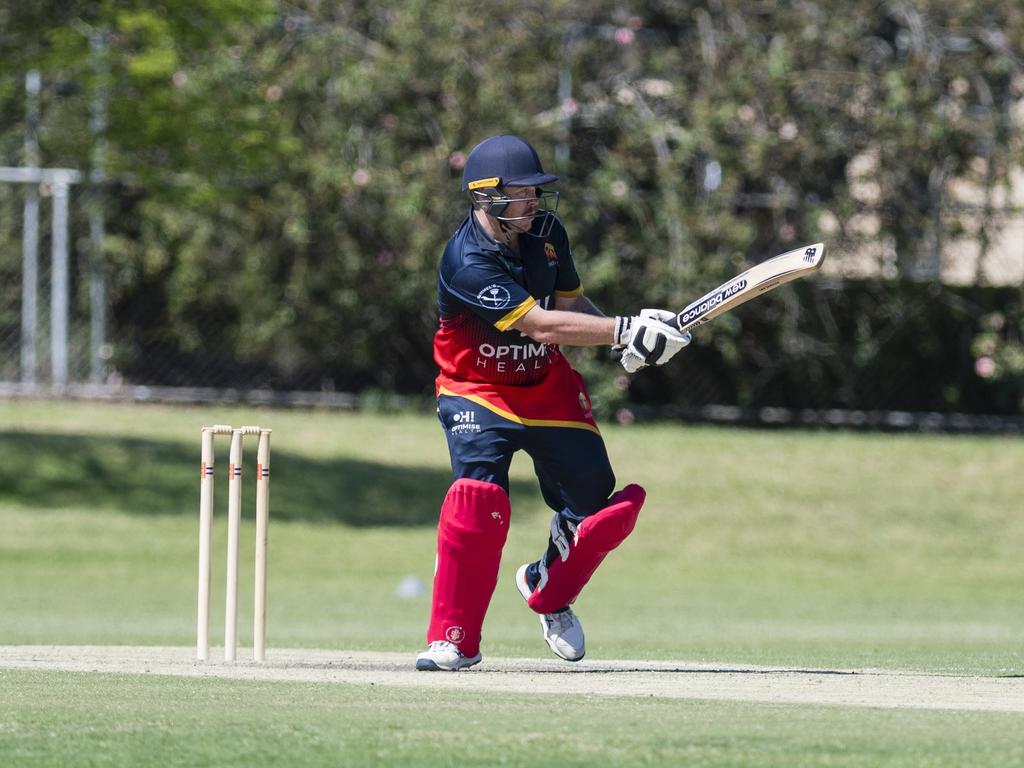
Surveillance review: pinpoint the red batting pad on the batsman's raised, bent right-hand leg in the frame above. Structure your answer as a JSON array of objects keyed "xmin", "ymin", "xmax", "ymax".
[{"xmin": 526, "ymin": 485, "xmax": 647, "ymax": 613}]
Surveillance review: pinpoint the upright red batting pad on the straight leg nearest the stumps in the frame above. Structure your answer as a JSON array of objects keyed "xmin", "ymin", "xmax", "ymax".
[{"xmin": 427, "ymin": 478, "xmax": 512, "ymax": 656}]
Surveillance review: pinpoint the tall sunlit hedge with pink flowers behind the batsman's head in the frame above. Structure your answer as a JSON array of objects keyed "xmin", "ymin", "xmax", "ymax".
[{"xmin": 0, "ymin": 0, "xmax": 1024, "ymax": 415}]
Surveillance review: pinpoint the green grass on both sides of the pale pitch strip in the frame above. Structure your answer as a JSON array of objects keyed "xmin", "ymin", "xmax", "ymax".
[{"xmin": 0, "ymin": 401, "xmax": 1024, "ymax": 766}]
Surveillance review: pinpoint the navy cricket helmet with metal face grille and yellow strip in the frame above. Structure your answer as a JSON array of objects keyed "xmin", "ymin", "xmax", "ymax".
[{"xmin": 462, "ymin": 134, "xmax": 558, "ymax": 238}]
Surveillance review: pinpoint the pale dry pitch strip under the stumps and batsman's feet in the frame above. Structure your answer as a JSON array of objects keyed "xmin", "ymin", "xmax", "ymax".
[{"xmin": 0, "ymin": 645, "xmax": 1024, "ymax": 712}]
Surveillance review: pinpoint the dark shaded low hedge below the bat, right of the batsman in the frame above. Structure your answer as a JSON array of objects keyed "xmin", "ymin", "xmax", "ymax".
[{"xmin": 604, "ymin": 281, "xmax": 1024, "ymax": 416}]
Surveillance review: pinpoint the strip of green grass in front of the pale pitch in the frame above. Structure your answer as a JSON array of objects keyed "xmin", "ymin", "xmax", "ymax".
[{"xmin": 0, "ymin": 672, "xmax": 1024, "ymax": 768}]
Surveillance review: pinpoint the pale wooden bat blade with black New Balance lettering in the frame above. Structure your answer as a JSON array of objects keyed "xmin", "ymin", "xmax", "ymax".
[{"xmin": 670, "ymin": 243, "xmax": 825, "ymax": 332}]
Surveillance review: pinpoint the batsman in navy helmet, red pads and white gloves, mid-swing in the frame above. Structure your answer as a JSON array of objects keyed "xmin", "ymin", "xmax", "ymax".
[{"xmin": 416, "ymin": 135, "xmax": 690, "ymax": 671}]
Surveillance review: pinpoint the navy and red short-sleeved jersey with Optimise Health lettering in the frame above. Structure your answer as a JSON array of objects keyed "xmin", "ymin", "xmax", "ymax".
[{"xmin": 434, "ymin": 213, "xmax": 593, "ymax": 424}]
